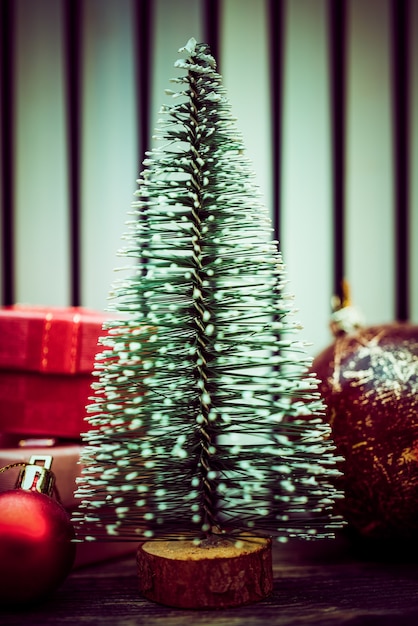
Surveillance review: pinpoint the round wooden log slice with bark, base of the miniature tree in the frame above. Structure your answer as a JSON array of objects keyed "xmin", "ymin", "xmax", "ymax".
[{"xmin": 137, "ymin": 536, "xmax": 273, "ymax": 609}]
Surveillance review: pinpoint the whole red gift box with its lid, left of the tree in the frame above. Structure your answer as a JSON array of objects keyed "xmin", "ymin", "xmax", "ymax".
[{"xmin": 0, "ymin": 306, "xmax": 110, "ymax": 438}]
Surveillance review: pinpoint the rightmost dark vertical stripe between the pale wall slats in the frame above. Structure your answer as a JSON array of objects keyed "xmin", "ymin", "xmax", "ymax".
[{"xmin": 391, "ymin": 0, "xmax": 410, "ymax": 321}]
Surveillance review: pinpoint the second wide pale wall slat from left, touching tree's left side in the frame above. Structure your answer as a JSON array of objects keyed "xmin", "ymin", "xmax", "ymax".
[{"xmin": 81, "ymin": 0, "xmax": 136, "ymax": 310}]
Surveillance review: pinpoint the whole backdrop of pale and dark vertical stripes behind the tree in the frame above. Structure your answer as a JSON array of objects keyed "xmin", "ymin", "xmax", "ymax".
[{"xmin": 0, "ymin": 0, "xmax": 418, "ymax": 353}]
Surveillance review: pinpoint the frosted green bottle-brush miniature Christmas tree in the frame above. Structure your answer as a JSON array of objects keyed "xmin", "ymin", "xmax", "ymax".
[{"xmin": 74, "ymin": 39, "xmax": 339, "ymax": 605}]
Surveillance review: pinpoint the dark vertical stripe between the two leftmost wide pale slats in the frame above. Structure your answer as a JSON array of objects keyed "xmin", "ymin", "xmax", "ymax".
[{"xmin": 64, "ymin": 0, "xmax": 81, "ymax": 306}]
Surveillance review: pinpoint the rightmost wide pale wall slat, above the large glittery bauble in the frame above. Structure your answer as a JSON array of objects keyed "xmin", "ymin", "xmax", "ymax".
[{"xmin": 346, "ymin": 0, "xmax": 395, "ymax": 324}]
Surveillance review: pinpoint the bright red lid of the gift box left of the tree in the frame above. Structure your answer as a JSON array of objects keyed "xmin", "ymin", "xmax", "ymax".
[{"xmin": 0, "ymin": 305, "xmax": 111, "ymax": 374}]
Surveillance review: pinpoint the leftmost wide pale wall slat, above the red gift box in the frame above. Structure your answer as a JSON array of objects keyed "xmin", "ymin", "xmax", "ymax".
[{"xmin": 15, "ymin": 0, "xmax": 70, "ymax": 305}]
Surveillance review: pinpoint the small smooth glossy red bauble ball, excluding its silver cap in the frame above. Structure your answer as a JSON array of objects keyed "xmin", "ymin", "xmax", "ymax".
[{"xmin": 0, "ymin": 489, "xmax": 75, "ymax": 605}]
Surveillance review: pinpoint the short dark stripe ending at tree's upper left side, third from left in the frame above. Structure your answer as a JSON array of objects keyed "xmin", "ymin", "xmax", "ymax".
[{"xmin": 133, "ymin": 0, "xmax": 153, "ymax": 163}]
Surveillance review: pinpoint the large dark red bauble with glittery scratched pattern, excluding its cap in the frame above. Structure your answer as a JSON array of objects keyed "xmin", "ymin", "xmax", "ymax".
[{"xmin": 312, "ymin": 324, "xmax": 418, "ymax": 540}]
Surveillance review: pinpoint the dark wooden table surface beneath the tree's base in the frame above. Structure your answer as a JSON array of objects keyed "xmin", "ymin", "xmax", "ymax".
[{"xmin": 0, "ymin": 537, "xmax": 418, "ymax": 626}]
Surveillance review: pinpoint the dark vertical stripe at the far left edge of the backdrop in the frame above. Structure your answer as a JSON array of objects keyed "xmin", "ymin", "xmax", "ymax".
[{"xmin": 0, "ymin": 0, "xmax": 15, "ymax": 305}]
